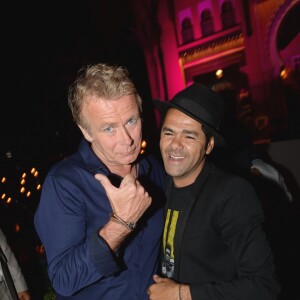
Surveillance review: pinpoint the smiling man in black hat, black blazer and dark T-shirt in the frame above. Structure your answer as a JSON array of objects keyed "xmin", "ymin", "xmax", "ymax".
[{"xmin": 148, "ymin": 83, "xmax": 280, "ymax": 300}]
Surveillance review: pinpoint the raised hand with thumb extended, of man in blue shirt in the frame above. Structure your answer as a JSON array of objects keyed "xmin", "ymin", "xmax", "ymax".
[{"xmin": 95, "ymin": 174, "xmax": 152, "ymax": 222}]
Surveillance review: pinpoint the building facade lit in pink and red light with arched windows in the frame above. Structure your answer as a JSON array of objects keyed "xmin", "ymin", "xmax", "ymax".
[{"xmin": 135, "ymin": 0, "xmax": 300, "ymax": 140}]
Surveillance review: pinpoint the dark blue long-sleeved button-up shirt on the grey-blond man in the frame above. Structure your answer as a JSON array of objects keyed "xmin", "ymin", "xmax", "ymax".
[{"xmin": 34, "ymin": 139, "xmax": 165, "ymax": 300}]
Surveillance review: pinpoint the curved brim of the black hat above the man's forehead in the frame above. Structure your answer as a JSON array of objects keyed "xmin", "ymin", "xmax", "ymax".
[{"xmin": 153, "ymin": 99, "xmax": 226, "ymax": 147}]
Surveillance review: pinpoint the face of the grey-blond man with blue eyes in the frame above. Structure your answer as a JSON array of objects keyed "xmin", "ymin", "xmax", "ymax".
[{"xmin": 80, "ymin": 95, "xmax": 142, "ymax": 174}]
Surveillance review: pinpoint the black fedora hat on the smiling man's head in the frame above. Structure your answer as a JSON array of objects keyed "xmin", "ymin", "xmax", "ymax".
[{"xmin": 153, "ymin": 82, "xmax": 225, "ymax": 146}]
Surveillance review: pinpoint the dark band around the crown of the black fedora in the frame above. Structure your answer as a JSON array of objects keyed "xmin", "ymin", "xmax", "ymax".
[{"xmin": 172, "ymin": 97, "xmax": 219, "ymax": 129}]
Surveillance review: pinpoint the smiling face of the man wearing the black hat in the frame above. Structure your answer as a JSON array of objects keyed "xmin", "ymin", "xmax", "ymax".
[{"xmin": 160, "ymin": 108, "xmax": 214, "ymax": 187}]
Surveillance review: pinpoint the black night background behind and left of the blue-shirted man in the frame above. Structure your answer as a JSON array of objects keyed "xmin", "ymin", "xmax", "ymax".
[{"xmin": 0, "ymin": 0, "xmax": 156, "ymax": 300}]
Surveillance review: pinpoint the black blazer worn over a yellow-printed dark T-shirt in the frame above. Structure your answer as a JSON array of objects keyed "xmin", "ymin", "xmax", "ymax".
[{"xmin": 166, "ymin": 162, "xmax": 280, "ymax": 300}]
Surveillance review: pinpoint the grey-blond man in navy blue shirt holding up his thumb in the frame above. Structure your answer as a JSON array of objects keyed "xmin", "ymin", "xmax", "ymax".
[{"xmin": 34, "ymin": 64, "xmax": 165, "ymax": 300}]
